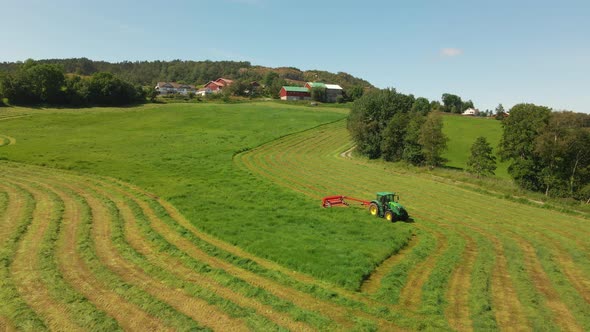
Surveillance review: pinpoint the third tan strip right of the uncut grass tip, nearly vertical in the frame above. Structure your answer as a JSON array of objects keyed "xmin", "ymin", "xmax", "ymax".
[{"xmin": 446, "ymin": 233, "xmax": 477, "ymax": 331}]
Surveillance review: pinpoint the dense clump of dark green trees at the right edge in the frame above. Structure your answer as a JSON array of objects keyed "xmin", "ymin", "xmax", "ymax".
[{"xmin": 499, "ymin": 104, "xmax": 590, "ymax": 203}]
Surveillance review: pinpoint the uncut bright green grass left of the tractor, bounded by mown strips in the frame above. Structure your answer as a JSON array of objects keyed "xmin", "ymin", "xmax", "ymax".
[{"xmin": 0, "ymin": 103, "xmax": 409, "ymax": 288}]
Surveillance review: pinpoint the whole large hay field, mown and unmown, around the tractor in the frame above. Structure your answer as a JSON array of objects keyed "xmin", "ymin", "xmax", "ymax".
[{"xmin": 0, "ymin": 103, "xmax": 590, "ymax": 331}]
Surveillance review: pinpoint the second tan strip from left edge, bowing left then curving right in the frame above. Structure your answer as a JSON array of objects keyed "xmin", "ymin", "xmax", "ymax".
[{"xmin": 11, "ymin": 184, "xmax": 81, "ymax": 331}]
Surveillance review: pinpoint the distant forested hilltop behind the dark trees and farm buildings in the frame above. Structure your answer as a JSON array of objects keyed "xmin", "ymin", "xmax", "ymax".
[{"xmin": 0, "ymin": 58, "xmax": 373, "ymax": 89}]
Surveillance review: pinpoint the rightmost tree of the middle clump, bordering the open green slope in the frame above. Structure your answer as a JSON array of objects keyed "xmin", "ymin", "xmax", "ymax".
[{"xmin": 418, "ymin": 112, "xmax": 448, "ymax": 168}]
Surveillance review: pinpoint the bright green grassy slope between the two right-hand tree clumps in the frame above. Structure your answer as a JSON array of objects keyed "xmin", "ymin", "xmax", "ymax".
[{"xmin": 443, "ymin": 116, "xmax": 510, "ymax": 179}]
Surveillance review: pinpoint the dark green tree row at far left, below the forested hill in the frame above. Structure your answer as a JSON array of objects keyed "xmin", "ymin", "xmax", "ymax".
[{"xmin": 0, "ymin": 60, "xmax": 147, "ymax": 106}]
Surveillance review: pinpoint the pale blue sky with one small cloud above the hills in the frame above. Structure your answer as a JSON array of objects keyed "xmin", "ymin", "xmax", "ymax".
[{"xmin": 0, "ymin": 0, "xmax": 590, "ymax": 113}]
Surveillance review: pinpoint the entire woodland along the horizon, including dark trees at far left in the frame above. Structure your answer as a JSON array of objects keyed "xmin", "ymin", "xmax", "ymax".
[{"xmin": 0, "ymin": 58, "xmax": 373, "ymax": 106}]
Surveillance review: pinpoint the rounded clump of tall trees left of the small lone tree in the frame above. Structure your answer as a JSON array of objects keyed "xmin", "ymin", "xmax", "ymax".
[{"xmin": 347, "ymin": 89, "xmax": 448, "ymax": 167}]
